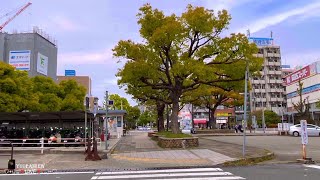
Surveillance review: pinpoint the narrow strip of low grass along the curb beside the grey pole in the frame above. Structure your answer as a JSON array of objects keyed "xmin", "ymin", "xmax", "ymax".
[{"xmin": 223, "ymin": 153, "xmax": 274, "ymax": 166}]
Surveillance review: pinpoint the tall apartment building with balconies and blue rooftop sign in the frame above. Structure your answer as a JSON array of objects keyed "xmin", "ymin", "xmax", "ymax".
[{"xmin": 249, "ymin": 37, "xmax": 286, "ymax": 114}]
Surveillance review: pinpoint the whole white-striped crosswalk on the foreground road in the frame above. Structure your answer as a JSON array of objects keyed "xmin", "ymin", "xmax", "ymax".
[{"xmin": 91, "ymin": 168, "xmax": 245, "ymax": 180}]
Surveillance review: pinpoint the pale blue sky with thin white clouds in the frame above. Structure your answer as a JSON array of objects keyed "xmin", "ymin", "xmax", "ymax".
[{"xmin": 0, "ymin": 0, "xmax": 320, "ymax": 104}]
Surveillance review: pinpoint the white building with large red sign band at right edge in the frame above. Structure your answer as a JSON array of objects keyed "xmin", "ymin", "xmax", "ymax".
[{"xmin": 285, "ymin": 61, "xmax": 320, "ymax": 118}]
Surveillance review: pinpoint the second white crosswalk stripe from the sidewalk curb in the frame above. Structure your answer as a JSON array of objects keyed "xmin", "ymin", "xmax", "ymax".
[{"xmin": 91, "ymin": 172, "xmax": 233, "ymax": 179}]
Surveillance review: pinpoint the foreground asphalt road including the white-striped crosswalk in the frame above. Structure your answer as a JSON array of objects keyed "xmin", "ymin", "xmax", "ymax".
[{"xmin": 0, "ymin": 164, "xmax": 320, "ymax": 180}]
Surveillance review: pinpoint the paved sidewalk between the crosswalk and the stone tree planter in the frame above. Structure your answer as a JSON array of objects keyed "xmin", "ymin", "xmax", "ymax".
[{"xmin": 0, "ymin": 131, "xmax": 265, "ymax": 170}]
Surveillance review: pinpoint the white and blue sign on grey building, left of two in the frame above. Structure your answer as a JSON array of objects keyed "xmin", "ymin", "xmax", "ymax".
[{"xmin": 9, "ymin": 50, "xmax": 31, "ymax": 71}]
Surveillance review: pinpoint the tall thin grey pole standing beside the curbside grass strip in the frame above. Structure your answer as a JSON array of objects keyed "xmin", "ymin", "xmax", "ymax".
[{"xmin": 242, "ymin": 62, "xmax": 249, "ymax": 157}]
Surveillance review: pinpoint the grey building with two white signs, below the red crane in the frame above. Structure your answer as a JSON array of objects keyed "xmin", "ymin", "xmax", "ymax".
[{"xmin": 0, "ymin": 28, "xmax": 58, "ymax": 80}]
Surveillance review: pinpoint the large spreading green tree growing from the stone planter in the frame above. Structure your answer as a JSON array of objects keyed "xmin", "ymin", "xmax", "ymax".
[{"xmin": 113, "ymin": 4, "xmax": 261, "ymax": 133}]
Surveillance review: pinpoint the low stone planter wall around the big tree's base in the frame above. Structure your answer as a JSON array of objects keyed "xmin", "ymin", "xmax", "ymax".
[{"xmin": 158, "ymin": 137, "xmax": 199, "ymax": 148}]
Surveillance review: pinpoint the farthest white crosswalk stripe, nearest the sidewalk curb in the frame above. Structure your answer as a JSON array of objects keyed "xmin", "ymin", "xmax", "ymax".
[{"xmin": 96, "ymin": 168, "xmax": 222, "ymax": 175}]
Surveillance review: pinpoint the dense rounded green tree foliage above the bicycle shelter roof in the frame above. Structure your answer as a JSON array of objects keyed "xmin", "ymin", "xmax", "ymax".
[{"xmin": 0, "ymin": 62, "xmax": 86, "ymax": 112}]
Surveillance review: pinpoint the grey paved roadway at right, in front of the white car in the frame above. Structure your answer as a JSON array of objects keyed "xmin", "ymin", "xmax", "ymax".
[{"xmin": 203, "ymin": 136, "xmax": 320, "ymax": 162}]
